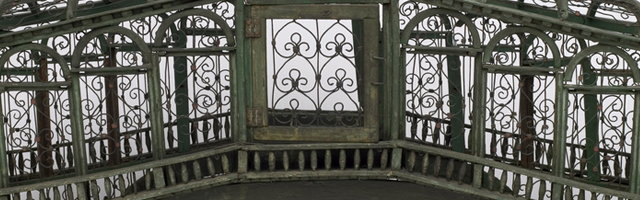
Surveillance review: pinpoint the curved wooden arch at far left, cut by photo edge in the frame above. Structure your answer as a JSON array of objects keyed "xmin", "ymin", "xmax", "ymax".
[{"xmin": 0, "ymin": 43, "xmax": 71, "ymax": 80}]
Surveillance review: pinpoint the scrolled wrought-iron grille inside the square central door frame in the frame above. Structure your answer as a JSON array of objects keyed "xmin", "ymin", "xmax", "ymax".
[{"xmin": 267, "ymin": 19, "xmax": 363, "ymax": 127}]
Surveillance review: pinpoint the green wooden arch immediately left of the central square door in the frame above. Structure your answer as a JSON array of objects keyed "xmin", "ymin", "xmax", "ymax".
[{"xmin": 153, "ymin": 9, "xmax": 236, "ymax": 47}]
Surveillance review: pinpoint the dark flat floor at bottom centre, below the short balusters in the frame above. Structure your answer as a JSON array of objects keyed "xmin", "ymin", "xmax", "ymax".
[{"xmin": 165, "ymin": 180, "xmax": 488, "ymax": 200}]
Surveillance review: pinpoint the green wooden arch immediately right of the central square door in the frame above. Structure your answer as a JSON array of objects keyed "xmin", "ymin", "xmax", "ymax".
[{"xmin": 400, "ymin": 8, "xmax": 481, "ymax": 48}]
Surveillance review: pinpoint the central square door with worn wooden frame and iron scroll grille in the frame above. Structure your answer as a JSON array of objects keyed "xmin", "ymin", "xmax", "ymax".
[{"xmin": 250, "ymin": 5, "xmax": 379, "ymax": 142}]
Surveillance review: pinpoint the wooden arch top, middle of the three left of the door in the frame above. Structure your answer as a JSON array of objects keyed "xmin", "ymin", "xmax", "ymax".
[{"xmin": 71, "ymin": 26, "xmax": 151, "ymax": 68}]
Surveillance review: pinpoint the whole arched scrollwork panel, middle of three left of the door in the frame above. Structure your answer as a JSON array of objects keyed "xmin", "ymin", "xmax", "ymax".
[{"xmin": 71, "ymin": 27, "xmax": 155, "ymax": 169}]
